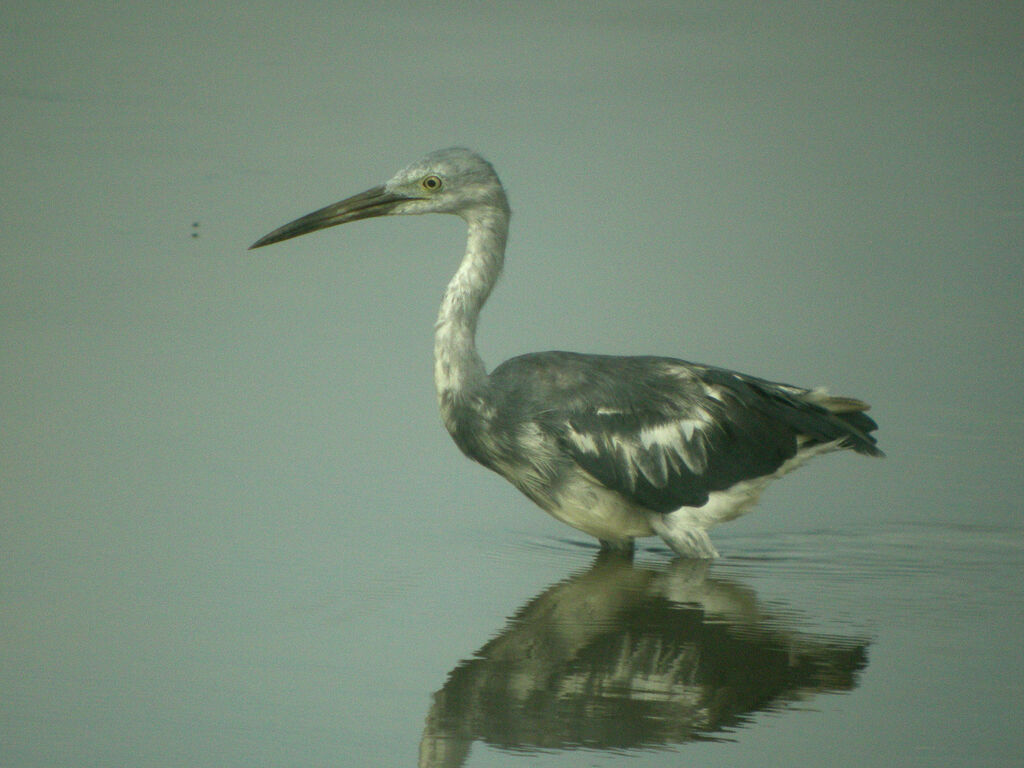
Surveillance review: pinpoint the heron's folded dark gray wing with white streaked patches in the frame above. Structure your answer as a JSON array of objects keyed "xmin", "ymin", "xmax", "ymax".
[{"xmin": 492, "ymin": 352, "xmax": 878, "ymax": 512}]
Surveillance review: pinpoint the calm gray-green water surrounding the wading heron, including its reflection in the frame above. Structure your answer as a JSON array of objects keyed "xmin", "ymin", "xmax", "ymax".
[{"xmin": 0, "ymin": 2, "xmax": 1024, "ymax": 768}]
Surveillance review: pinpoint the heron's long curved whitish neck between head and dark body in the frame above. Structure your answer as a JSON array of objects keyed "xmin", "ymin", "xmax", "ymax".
[{"xmin": 434, "ymin": 208, "xmax": 509, "ymax": 415}]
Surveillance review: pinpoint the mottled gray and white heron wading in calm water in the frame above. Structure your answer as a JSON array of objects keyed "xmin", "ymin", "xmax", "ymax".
[{"xmin": 250, "ymin": 147, "xmax": 883, "ymax": 559}]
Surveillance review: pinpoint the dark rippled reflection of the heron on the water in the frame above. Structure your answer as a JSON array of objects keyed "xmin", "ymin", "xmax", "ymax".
[{"xmin": 420, "ymin": 553, "xmax": 867, "ymax": 768}]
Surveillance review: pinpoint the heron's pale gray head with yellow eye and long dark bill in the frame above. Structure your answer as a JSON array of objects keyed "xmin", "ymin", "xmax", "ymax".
[{"xmin": 250, "ymin": 147, "xmax": 509, "ymax": 249}]
